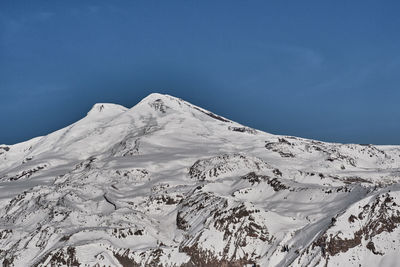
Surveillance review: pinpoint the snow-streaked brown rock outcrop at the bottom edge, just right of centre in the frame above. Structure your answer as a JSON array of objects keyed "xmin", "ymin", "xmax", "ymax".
[{"xmin": 177, "ymin": 191, "xmax": 273, "ymax": 266}]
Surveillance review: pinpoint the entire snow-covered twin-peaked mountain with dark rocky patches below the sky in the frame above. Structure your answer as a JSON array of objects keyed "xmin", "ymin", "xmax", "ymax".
[{"xmin": 0, "ymin": 94, "xmax": 400, "ymax": 266}]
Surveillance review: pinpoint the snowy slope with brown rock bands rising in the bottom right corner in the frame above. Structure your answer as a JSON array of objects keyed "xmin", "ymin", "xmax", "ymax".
[{"xmin": 298, "ymin": 191, "xmax": 400, "ymax": 266}]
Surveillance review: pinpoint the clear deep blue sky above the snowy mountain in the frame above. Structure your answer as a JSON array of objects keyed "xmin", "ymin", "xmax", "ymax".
[{"xmin": 0, "ymin": 0, "xmax": 400, "ymax": 144}]
